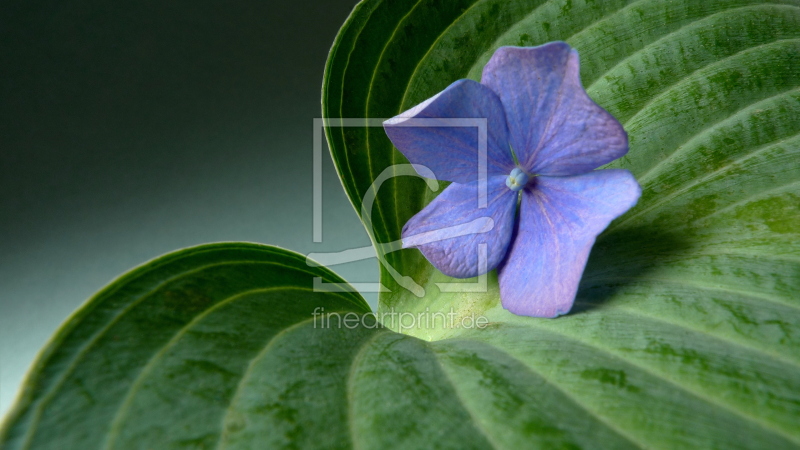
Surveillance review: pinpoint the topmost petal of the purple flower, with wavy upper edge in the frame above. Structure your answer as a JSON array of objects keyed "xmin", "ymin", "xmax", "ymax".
[{"xmin": 481, "ymin": 42, "xmax": 628, "ymax": 176}]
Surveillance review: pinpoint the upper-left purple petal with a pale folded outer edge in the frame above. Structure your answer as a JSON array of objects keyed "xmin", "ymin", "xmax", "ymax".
[{"xmin": 383, "ymin": 80, "xmax": 514, "ymax": 183}]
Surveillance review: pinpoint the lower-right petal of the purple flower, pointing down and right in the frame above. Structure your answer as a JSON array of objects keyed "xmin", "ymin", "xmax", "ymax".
[{"xmin": 498, "ymin": 169, "xmax": 641, "ymax": 317}]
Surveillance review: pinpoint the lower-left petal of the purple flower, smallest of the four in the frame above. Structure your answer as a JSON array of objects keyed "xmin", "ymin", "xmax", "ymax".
[{"xmin": 402, "ymin": 176, "xmax": 517, "ymax": 278}]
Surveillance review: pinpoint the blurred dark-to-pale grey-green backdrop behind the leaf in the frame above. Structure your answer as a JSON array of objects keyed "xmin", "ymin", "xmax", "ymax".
[{"xmin": 0, "ymin": 0, "xmax": 378, "ymax": 414}]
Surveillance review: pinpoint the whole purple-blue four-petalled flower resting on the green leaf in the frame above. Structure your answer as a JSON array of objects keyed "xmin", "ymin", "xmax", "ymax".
[{"xmin": 384, "ymin": 42, "xmax": 641, "ymax": 317}]
